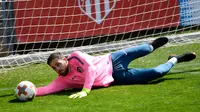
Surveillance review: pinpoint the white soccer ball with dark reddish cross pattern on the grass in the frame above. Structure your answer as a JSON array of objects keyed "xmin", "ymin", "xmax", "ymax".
[{"xmin": 15, "ymin": 81, "xmax": 36, "ymax": 101}]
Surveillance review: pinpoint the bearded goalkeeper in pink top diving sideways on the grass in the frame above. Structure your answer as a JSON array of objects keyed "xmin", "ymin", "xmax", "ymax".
[{"xmin": 36, "ymin": 37, "xmax": 196, "ymax": 98}]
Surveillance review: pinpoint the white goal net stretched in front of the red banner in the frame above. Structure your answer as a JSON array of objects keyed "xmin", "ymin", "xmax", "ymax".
[{"xmin": 0, "ymin": 0, "xmax": 200, "ymax": 70}]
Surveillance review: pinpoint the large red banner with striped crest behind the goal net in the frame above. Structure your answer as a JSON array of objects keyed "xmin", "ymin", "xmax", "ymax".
[{"xmin": 14, "ymin": 0, "xmax": 180, "ymax": 42}]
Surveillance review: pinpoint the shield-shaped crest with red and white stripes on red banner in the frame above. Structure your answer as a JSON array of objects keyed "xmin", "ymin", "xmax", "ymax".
[{"xmin": 78, "ymin": 0, "xmax": 117, "ymax": 24}]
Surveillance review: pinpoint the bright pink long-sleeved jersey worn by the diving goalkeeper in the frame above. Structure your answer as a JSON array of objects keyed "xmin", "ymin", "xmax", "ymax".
[{"xmin": 36, "ymin": 51, "xmax": 114, "ymax": 96}]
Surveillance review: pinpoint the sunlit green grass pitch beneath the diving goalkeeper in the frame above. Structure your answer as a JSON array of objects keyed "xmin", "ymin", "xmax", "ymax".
[{"xmin": 0, "ymin": 44, "xmax": 200, "ymax": 112}]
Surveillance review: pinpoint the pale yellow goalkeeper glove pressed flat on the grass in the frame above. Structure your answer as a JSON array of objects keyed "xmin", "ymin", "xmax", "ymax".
[{"xmin": 69, "ymin": 88, "xmax": 90, "ymax": 99}]
